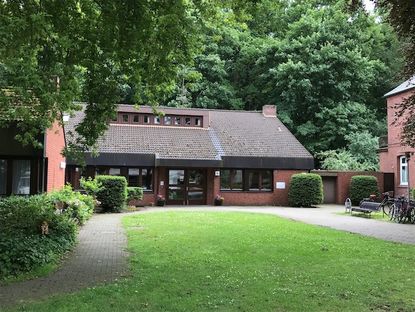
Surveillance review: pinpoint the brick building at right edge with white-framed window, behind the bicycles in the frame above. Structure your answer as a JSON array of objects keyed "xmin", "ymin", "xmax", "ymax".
[{"xmin": 379, "ymin": 76, "xmax": 415, "ymax": 195}]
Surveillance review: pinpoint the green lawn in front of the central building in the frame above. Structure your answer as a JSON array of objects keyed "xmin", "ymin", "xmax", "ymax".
[{"xmin": 6, "ymin": 212, "xmax": 415, "ymax": 312}]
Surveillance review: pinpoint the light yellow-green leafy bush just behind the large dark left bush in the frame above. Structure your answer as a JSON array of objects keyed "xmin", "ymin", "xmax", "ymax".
[{"xmin": 47, "ymin": 185, "xmax": 95, "ymax": 225}]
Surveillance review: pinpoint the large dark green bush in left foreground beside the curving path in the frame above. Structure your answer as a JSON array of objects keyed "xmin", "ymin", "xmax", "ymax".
[{"xmin": 0, "ymin": 195, "xmax": 77, "ymax": 279}]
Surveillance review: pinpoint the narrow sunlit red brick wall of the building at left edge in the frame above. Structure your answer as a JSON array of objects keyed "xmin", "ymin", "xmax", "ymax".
[{"xmin": 45, "ymin": 121, "xmax": 65, "ymax": 192}]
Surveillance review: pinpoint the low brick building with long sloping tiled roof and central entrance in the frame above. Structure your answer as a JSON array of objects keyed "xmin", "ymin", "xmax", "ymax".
[{"xmin": 65, "ymin": 105, "xmax": 314, "ymax": 205}]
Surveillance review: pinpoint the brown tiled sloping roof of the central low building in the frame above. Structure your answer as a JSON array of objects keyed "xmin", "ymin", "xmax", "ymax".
[{"xmin": 65, "ymin": 105, "xmax": 313, "ymax": 169}]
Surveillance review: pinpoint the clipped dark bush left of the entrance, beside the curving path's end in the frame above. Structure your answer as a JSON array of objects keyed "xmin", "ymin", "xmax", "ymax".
[{"xmin": 95, "ymin": 175, "xmax": 127, "ymax": 212}]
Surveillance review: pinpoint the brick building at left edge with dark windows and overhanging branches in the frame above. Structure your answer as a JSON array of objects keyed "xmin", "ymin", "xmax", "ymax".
[{"xmin": 0, "ymin": 122, "xmax": 65, "ymax": 196}]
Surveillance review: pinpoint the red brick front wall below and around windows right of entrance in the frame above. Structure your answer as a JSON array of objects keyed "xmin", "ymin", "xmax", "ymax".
[{"xmin": 213, "ymin": 170, "xmax": 305, "ymax": 206}]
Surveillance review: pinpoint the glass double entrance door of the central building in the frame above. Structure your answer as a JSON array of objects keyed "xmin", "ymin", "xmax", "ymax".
[{"xmin": 167, "ymin": 169, "xmax": 206, "ymax": 205}]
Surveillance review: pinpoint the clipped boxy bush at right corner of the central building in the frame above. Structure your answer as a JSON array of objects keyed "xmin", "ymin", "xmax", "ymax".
[{"xmin": 288, "ymin": 173, "xmax": 323, "ymax": 207}]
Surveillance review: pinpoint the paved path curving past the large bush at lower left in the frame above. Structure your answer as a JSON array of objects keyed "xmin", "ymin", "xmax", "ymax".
[{"xmin": 0, "ymin": 214, "xmax": 128, "ymax": 310}]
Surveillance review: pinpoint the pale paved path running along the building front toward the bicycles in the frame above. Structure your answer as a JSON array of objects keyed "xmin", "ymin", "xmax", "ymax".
[{"xmin": 142, "ymin": 205, "xmax": 415, "ymax": 244}]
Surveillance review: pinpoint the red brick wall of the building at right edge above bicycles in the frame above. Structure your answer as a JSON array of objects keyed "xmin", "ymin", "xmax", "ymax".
[{"xmin": 379, "ymin": 90, "xmax": 415, "ymax": 195}]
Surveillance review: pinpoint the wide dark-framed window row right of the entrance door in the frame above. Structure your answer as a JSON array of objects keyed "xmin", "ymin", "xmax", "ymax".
[{"xmin": 220, "ymin": 169, "xmax": 273, "ymax": 192}]
